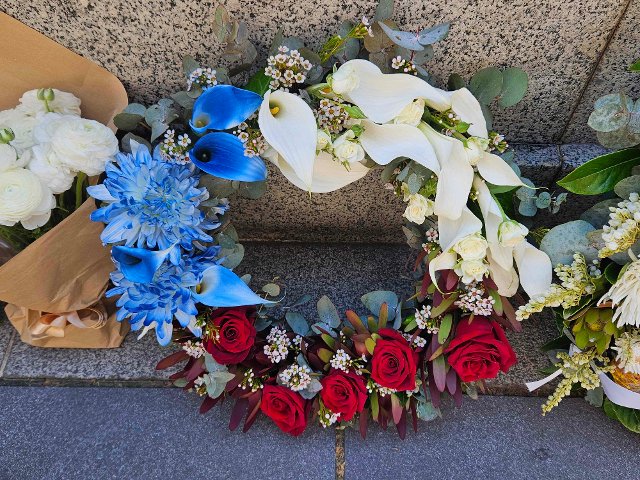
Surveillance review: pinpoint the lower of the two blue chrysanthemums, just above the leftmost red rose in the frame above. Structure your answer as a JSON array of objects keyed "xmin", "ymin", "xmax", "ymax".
[{"xmin": 107, "ymin": 247, "xmax": 220, "ymax": 346}]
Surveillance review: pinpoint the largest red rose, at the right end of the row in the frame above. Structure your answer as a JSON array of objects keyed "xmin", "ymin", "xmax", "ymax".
[{"xmin": 445, "ymin": 317, "xmax": 516, "ymax": 382}]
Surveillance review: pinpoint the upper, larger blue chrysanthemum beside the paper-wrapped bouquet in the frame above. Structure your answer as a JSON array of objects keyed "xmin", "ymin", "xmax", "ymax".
[{"xmin": 88, "ymin": 146, "xmax": 228, "ymax": 251}]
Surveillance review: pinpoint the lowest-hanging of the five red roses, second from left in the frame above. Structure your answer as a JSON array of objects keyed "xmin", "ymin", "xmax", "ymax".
[{"xmin": 260, "ymin": 385, "xmax": 307, "ymax": 437}]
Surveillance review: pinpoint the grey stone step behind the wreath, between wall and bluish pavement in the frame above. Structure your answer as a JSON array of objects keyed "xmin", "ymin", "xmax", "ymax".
[{"xmin": 0, "ymin": 242, "xmax": 556, "ymax": 395}]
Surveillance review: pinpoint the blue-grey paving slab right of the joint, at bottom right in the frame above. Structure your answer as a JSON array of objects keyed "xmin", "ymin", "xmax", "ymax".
[{"xmin": 346, "ymin": 397, "xmax": 640, "ymax": 480}]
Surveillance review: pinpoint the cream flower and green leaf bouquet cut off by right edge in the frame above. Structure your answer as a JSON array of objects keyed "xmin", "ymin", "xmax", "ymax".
[{"xmin": 517, "ymin": 58, "xmax": 640, "ymax": 433}]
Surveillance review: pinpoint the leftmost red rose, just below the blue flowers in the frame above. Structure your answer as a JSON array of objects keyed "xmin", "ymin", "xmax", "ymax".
[{"xmin": 204, "ymin": 307, "xmax": 256, "ymax": 365}]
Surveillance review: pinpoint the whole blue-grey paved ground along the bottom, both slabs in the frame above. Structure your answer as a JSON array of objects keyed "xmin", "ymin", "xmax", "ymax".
[{"xmin": 0, "ymin": 387, "xmax": 640, "ymax": 480}]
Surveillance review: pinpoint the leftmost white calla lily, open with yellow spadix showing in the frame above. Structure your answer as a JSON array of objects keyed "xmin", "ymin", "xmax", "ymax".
[{"xmin": 258, "ymin": 91, "xmax": 318, "ymax": 190}]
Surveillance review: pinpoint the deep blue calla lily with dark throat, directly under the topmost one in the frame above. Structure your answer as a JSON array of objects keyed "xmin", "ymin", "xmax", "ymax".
[{"xmin": 189, "ymin": 132, "xmax": 267, "ymax": 182}]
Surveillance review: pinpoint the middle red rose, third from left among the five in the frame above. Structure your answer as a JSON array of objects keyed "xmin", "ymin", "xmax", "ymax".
[{"xmin": 320, "ymin": 369, "xmax": 367, "ymax": 422}]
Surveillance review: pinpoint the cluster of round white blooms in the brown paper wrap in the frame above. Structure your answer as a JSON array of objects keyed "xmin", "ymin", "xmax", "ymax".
[{"xmin": 0, "ymin": 89, "xmax": 118, "ymax": 230}]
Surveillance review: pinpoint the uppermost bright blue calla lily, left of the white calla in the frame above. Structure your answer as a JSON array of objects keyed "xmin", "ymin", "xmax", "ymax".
[{"xmin": 190, "ymin": 85, "xmax": 262, "ymax": 134}]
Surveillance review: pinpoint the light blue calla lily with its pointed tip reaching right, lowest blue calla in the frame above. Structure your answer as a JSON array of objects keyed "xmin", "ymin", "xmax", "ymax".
[{"xmin": 192, "ymin": 265, "xmax": 274, "ymax": 307}]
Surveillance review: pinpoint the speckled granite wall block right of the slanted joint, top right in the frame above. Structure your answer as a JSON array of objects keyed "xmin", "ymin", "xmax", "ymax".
[{"xmin": 562, "ymin": 0, "xmax": 640, "ymax": 142}]
